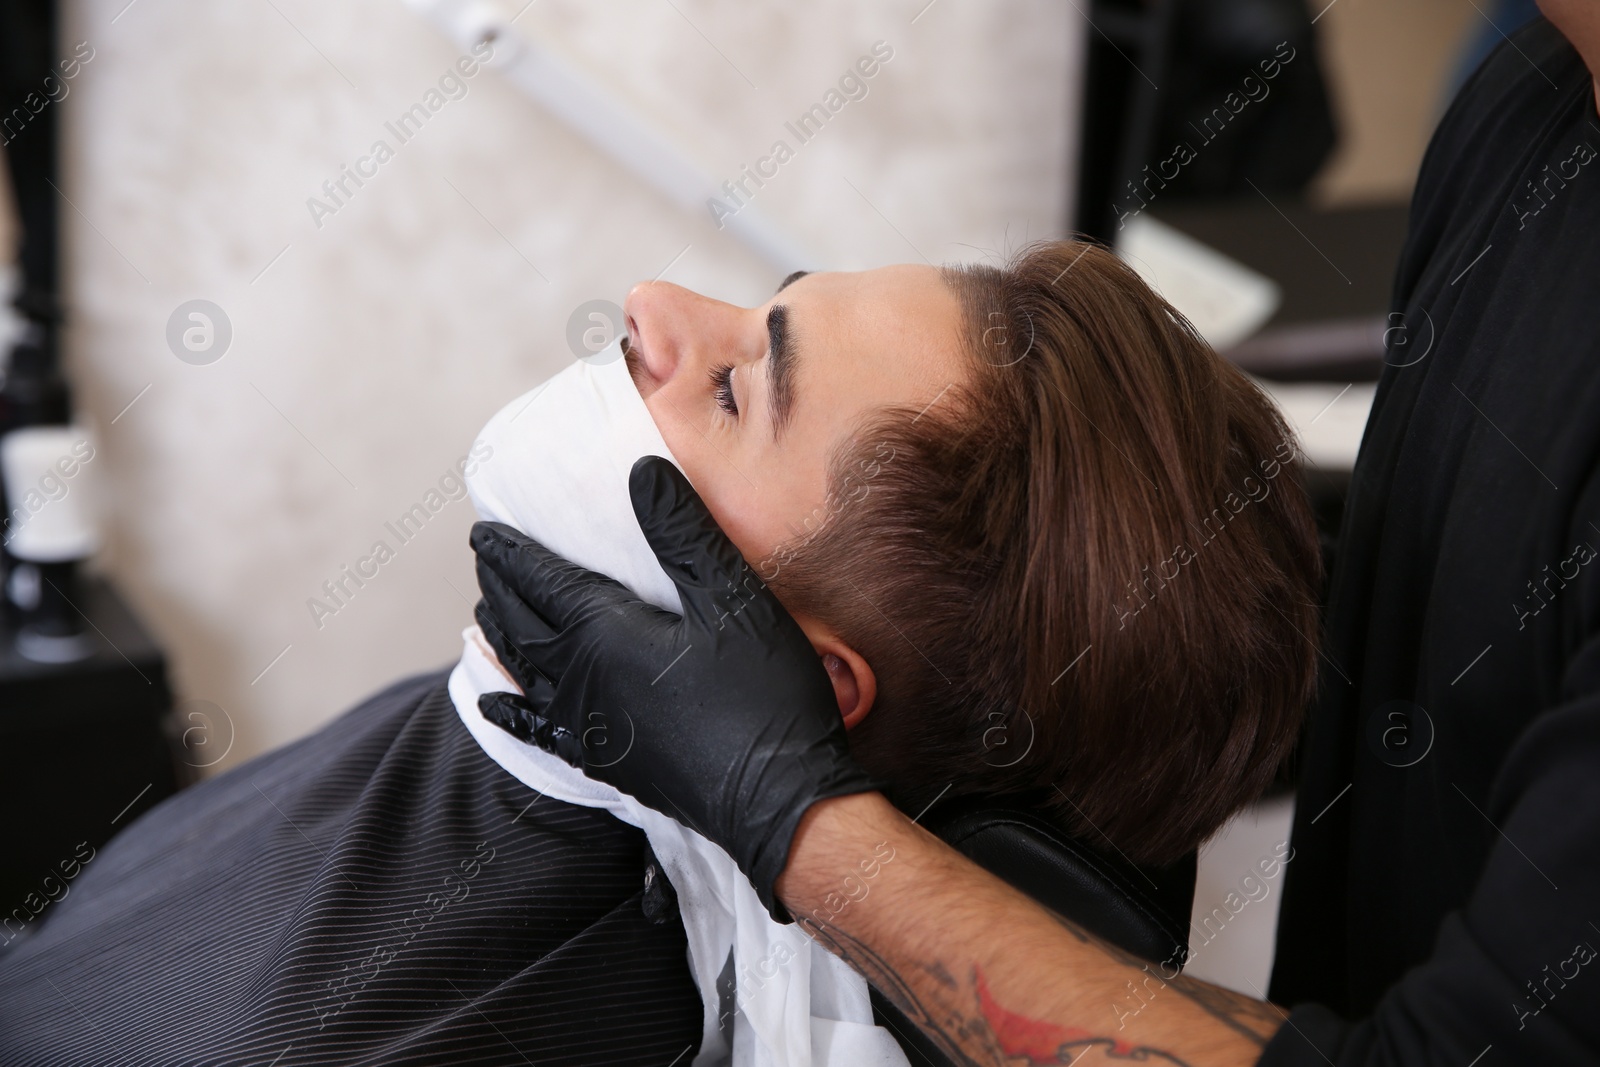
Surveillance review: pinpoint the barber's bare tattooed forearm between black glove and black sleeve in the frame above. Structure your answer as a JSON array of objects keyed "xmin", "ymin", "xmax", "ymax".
[{"xmin": 778, "ymin": 793, "xmax": 1283, "ymax": 1067}]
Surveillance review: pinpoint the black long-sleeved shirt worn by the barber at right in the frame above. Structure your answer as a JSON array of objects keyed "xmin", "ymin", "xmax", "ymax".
[{"xmin": 1261, "ymin": 19, "xmax": 1600, "ymax": 1067}]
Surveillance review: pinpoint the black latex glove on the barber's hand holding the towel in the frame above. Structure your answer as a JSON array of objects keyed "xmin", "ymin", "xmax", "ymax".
[{"xmin": 472, "ymin": 456, "xmax": 878, "ymax": 921}]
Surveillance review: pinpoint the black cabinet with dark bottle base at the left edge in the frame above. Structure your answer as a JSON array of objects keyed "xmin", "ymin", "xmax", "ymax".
[{"xmin": 0, "ymin": 577, "xmax": 180, "ymax": 952}]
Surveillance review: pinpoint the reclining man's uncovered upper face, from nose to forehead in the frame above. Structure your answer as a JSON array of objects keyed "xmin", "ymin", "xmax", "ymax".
[{"xmin": 626, "ymin": 266, "xmax": 966, "ymax": 565}]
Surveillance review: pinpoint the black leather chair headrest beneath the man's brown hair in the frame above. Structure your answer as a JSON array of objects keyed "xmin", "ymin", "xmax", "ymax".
[{"xmin": 872, "ymin": 800, "xmax": 1195, "ymax": 1067}]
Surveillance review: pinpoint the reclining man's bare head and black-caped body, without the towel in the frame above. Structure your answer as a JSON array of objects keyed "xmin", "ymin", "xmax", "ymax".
[{"xmin": 0, "ymin": 243, "xmax": 1318, "ymax": 1067}]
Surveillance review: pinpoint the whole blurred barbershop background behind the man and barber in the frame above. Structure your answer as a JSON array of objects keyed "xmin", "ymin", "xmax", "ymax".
[{"xmin": 0, "ymin": 0, "xmax": 1531, "ymax": 992}]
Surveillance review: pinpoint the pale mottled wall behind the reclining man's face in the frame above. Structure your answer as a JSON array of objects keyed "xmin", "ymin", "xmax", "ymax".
[{"xmin": 53, "ymin": 0, "xmax": 1082, "ymax": 766}]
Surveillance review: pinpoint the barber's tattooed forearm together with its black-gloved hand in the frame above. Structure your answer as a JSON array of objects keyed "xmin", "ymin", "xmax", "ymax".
[{"xmin": 472, "ymin": 459, "xmax": 1283, "ymax": 1065}]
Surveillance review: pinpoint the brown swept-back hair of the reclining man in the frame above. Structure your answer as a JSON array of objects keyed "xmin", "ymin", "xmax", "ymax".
[{"xmin": 768, "ymin": 242, "xmax": 1322, "ymax": 864}]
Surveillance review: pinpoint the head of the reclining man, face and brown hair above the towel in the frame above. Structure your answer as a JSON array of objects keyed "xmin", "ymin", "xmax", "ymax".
[{"xmin": 627, "ymin": 242, "xmax": 1320, "ymax": 864}]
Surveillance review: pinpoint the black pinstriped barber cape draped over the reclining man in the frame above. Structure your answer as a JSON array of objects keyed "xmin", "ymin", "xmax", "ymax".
[{"xmin": 0, "ymin": 675, "xmax": 702, "ymax": 1067}]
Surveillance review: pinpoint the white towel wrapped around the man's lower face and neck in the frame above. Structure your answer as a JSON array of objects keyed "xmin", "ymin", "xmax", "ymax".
[{"xmin": 450, "ymin": 346, "xmax": 906, "ymax": 1067}]
